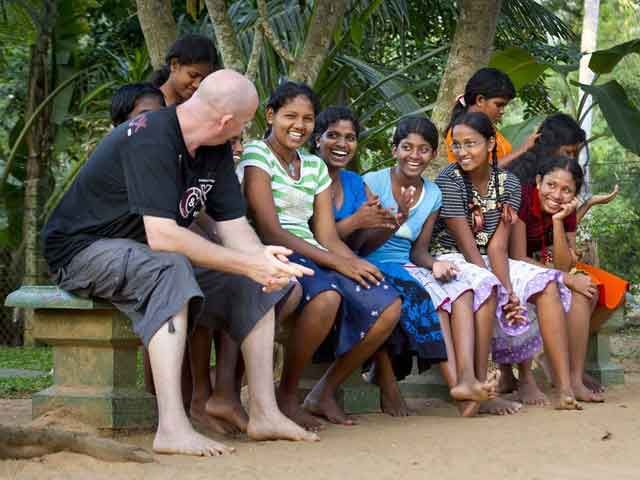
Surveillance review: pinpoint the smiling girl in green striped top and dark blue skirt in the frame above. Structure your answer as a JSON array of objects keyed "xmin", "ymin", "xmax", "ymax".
[{"xmin": 239, "ymin": 82, "xmax": 401, "ymax": 429}]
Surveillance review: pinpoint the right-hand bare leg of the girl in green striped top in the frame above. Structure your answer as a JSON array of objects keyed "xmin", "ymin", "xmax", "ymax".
[{"xmin": 304, "ymin": 299, "xmax": 402, "ymax": 425}]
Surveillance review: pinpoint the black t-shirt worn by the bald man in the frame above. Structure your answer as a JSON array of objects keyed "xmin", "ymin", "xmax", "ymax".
[{"xmin": 42, "ymin": 107, "xmax": 245, "ymax": 272}]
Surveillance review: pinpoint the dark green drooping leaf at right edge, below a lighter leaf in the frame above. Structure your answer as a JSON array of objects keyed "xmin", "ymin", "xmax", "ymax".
[{"xmin": 576, "ymin": 80, "xmax": 640, "ymax": 155}]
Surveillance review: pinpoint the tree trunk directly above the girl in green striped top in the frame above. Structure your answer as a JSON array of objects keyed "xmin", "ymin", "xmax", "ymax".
[{"xmin": 290, "ymin": 0, "xmax": 348, "ymax": 86}]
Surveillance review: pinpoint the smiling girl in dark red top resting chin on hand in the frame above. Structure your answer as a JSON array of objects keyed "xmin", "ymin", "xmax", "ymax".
[{"xmin": 511, "ymin": 156, "xmax": 629, "ymax": 402}]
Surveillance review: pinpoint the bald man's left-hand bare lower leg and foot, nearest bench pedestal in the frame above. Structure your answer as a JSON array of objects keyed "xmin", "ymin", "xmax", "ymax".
[{"xmin": 149, "ymin": 304, "xmax": 233, "ymax": 456}]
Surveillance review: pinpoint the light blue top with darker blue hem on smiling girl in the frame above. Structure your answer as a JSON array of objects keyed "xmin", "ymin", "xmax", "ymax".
[{"xmin": 364, "ymin": 168, "xmax": 442, "ymax": 264}]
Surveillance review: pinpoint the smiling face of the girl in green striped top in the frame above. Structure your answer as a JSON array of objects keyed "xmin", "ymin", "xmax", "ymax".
[{"xmin": 266, "ymin": 95, "xmax": 315, "ymax": 151}]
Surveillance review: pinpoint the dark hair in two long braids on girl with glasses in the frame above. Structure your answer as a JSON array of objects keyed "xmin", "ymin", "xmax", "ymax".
[{"xmin": 451, "ymin": 112, "xmax": 515, "ymax": 232}]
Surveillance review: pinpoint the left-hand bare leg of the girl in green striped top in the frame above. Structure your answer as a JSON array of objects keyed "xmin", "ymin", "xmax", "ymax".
[{"xmin": 278, "ymin": 290, "xmax": 342, "ymax": 430}]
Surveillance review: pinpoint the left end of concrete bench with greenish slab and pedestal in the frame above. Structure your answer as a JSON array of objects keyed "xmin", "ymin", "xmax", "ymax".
[{"xmin": 5, "ymin": 286, "xmax": 157, "ymax": 434}]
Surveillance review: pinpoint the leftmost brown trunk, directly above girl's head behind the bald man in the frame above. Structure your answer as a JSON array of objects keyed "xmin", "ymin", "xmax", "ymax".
[{"xmin": 136, "ymin": 0, "xmax": 178, "ymax": 69}]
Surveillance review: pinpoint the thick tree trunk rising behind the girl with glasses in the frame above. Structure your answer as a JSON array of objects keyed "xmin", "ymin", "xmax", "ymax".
[{"xmin": 427, "ymin": 0, "xmax": 502, "ymax": 175}]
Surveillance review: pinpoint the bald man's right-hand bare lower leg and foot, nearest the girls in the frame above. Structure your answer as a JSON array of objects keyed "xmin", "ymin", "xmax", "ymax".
[{"xmin": 240, "ymin": 309, "xmax": 319, "ymax": 441}]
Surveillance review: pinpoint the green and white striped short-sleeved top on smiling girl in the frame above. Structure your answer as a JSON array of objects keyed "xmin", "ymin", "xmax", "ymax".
[{"xmin": 238, "ymin": 140, "xmax": 331, "ymax": 248}]
